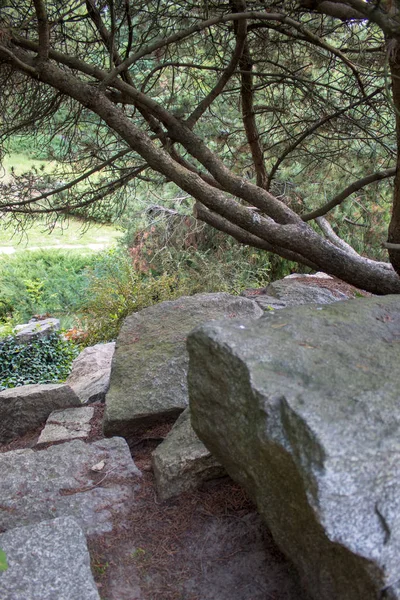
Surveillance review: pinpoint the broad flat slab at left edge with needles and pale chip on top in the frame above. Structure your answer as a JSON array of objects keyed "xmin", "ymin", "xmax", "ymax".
[{"xmin": 0, "ymin": 438, "xmax": 140, "ymax": 535}]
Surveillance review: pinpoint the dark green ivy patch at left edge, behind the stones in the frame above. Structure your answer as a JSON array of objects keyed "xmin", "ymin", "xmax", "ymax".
[{"xmin": 0, "ymin": 333, "xmax": 79, "ymax": 390}]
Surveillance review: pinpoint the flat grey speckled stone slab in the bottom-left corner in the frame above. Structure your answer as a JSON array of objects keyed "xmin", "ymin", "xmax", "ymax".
[{"xmin": 0, "ymin": 517, "xmax": 100, "ymax": 600}]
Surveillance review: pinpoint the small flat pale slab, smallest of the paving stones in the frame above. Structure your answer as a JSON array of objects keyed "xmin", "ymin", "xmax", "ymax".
[{"xmin": 37, "ymin": 406, "xmax": 94, "ymax": 445}]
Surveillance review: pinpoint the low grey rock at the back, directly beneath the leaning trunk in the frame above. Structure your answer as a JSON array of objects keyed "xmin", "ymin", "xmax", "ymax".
[{"xmin": 243, "ymin": 274, "xmax": 349, "ymax": 311}]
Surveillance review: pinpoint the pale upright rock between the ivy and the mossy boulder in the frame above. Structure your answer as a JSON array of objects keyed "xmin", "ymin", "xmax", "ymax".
[{"xmin": 66, "ymin": 342, "xmax": 115, "ymax": 403}]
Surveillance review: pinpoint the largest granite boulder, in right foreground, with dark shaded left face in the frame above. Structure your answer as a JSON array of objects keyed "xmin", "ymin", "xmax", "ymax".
[{"xmin": 188, "ymin": 296, "xmax": 400, "ymax": 600}]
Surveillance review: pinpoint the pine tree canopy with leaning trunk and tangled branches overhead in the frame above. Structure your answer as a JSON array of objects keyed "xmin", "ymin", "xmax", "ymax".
[{"xmin": 0, "ymin": 0, "xmax": 400, "ymax": 294}]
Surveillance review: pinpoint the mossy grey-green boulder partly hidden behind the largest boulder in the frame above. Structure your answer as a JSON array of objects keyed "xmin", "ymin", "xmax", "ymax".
[{"xmin": 104, "ymin": 293, "xmax": 262, "ymax": 439}]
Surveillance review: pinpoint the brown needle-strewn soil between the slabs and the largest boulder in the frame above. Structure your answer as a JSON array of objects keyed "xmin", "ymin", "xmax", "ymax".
[{"xmin": 0, "ymin": 403, "xmax": 308, "ymax": 600}]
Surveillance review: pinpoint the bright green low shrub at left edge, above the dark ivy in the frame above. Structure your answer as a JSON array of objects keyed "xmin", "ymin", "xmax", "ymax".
[{"xmin": 0, "ymin": 250, "xmax": 95, "ymax": 323}]
